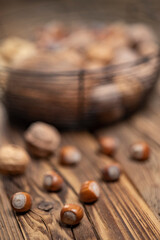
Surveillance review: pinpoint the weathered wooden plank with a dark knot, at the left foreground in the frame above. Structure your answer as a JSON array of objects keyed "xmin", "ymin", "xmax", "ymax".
[{"xmin": 0, "ymin": 106, "xmax": 97, "ymax": 240}]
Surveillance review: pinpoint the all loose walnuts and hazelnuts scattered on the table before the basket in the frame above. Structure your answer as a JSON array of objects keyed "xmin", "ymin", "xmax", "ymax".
[{"xmin": 0, "ymin": 122, "xmax": 150, "ymax": 226}]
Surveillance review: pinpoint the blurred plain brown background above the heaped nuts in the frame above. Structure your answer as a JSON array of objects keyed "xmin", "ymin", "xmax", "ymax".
[{"xmin": 0, "ymin": 0, "xmax": 160, "ymax": 38}]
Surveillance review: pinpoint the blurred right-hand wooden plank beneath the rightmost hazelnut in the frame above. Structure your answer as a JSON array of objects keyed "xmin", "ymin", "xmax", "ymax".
[{"xmin": 97, "ymin": 80, "xmax": 160, "ymax": 219}]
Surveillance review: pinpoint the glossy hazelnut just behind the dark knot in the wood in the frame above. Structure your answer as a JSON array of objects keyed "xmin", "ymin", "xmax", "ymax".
[{"xmin": 43, "ymin": 171, "xmax": 63, "ymax": 192}]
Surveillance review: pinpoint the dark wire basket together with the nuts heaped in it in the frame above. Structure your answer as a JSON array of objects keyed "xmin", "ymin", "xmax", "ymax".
[{"xmin": 0, "ymin": 22, "xmax": 159, "ymax": 128}]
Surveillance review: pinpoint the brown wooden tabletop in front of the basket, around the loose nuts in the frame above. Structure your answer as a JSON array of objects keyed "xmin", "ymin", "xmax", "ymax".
[{"xmin": 0, "ymin": 79, "xmax": 160, "ymax": 240}]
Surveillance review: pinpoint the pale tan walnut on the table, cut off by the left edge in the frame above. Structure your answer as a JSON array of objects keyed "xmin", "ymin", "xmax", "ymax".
[{"xmin": 0, "ymin": 144, "xmax": 30, "ymax": 175}]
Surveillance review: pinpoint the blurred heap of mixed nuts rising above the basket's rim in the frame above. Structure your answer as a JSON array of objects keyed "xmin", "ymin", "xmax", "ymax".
[{"xmin": 0, "ymin": 22, "xmax": 158, "ymax": 71}]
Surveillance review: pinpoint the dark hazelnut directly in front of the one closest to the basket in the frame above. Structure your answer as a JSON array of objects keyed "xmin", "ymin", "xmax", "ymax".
[{"xmin": 102, "ymin": 164, "xmax": 121, "ymax": 182}]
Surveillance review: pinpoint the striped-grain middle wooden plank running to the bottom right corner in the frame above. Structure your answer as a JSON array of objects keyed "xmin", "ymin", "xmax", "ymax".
[{"xmin": 52, "ymin": 133, "xmax": 160, "ymax": 239}]
